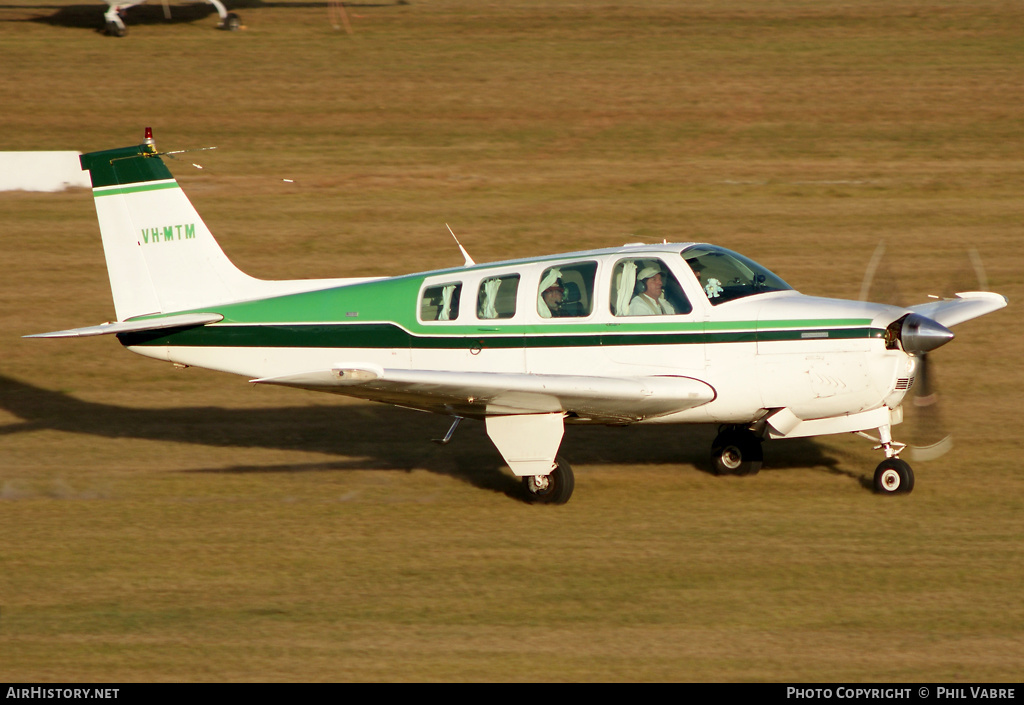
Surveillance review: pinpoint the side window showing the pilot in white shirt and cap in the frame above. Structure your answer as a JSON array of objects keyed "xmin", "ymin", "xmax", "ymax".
[{"xmin": 611, "ymin": 258, "xmax": 693, "ymax": 316}]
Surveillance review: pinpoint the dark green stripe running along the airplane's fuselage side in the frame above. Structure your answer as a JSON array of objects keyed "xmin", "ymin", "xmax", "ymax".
[{"xmin": 118, "ymin": 323, "xmax": 885, "ymax": 349}]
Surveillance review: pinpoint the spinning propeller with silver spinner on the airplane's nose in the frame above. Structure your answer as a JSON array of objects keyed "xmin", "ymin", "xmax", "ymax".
[{"xmin": 860, "ymin": 240, "xmax": 988, "ymax": 461}]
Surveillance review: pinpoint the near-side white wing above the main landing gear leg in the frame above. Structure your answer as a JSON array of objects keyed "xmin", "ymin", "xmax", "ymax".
[{"xmin": 251, "ymin": 364, "xmax": 715, "ymax": 423}]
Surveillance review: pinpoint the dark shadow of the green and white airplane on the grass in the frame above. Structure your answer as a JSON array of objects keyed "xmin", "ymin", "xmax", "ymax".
[{"xmin": 0, "ymin": 375, "xmax": 851, "ymax": 499}]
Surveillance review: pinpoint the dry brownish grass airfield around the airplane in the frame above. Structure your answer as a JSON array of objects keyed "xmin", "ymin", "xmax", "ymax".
[{"xmin": 0, "ymin": 0, "xmax": 1024, "ymax": 682}]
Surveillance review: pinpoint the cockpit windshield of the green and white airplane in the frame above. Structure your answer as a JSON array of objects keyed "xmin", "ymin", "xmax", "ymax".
[{"xmin": 681, "ymin": 245, "xmax": 793, "ymax": 305}]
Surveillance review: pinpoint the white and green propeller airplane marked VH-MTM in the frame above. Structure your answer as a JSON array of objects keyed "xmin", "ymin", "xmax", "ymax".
[{"xmin": 30, "ymin": 130, "xmax": 1007, "ymax": 503}]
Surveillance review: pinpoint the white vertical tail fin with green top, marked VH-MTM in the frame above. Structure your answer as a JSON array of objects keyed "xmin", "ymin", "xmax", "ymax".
[{"xmin": 81, "ymin": 130, "xmax": 273, "ymax": 321}]
